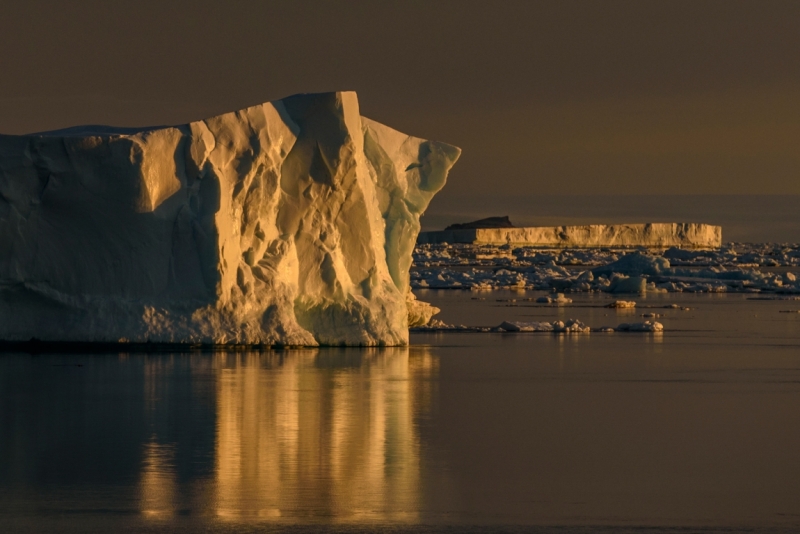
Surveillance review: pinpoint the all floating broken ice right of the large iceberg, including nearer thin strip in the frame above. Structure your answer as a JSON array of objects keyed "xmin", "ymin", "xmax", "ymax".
[{"xmin": 411, "ymin": 243, "xmax": 800, "ymax": 334}]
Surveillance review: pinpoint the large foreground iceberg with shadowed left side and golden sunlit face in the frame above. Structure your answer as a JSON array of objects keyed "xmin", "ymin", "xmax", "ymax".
[{"xmin": 0, "ymin": 92, "xmax": 460, "ymax": 345}]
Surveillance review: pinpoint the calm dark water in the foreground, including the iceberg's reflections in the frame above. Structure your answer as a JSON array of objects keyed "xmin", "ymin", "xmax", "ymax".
[{"xmin": 0, "ymin": 292, "xmax": 800, "ymax": 532}]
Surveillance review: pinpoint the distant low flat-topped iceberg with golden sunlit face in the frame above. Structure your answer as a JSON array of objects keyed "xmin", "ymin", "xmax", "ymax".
[{"xmin": 417, "ymin": 223, "xmax": 722, "ymax": 248}]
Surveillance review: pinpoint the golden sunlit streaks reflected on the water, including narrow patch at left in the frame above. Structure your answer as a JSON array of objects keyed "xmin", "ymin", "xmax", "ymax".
[{"xmin": 141, "ymin": 348, "xmax": 438, "ymax": 523}]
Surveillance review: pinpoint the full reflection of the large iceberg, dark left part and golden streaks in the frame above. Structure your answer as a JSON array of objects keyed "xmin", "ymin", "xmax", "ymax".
[{"xmin": 0, "ymin": 347, "xmax": 438, "ymax": 532}]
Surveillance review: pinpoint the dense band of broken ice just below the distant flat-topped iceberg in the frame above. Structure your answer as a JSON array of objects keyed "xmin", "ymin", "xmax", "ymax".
[{"xmin": 411, "ymin": 243, "xmax": 800, "ymax": 294}]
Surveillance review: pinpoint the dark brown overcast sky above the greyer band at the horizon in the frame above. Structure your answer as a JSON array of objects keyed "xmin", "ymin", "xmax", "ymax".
[{"xmin": 0, "ymin": 0, "xmax": 800, "ymax": 202}]
